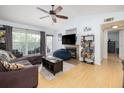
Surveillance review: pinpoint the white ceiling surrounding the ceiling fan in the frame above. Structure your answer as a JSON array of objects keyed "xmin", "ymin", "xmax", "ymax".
[{"xmin": 0, "ymin": 5, "xmax": 124, "ymax": 29}]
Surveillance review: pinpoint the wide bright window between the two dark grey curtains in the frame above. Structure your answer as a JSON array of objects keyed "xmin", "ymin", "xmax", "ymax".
[{"xmin": 12, "ymin": 28, "xmax": 40, "ymax": 55}]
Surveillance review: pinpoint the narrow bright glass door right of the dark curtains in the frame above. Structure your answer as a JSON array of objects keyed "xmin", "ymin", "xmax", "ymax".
[{"xmin": 46, "ymin": 35, "xmax": 53, "ymax": 55}]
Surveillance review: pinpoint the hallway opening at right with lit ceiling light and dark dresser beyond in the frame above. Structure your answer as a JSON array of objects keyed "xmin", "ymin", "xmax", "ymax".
[{"xmin": 101, "ymin": 20, "xmax": 124, "ymax": 59}]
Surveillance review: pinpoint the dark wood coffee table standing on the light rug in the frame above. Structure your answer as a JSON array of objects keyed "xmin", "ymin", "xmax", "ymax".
[{"xmin": 42, "ymin": 57, "xmax": 63, "ymax": 75}]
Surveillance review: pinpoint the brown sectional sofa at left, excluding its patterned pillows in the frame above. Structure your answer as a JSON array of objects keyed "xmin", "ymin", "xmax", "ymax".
[{"xmin": 0, "ymin": 49, "xmax": 41, "ymax": 88}]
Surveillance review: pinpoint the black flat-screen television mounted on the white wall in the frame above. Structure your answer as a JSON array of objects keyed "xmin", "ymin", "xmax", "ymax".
[{"xmin": 62, "ymin": 34, "xmax": 76, "ymax": 45}]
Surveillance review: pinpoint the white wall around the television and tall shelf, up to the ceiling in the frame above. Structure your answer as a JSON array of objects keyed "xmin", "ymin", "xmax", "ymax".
[{"xmin": 55, "ymin": 12, "xmax": 124, "ymax": 65}]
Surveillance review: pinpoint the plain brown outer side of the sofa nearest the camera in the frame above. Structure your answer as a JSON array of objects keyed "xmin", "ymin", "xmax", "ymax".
[{"xmin": 0, "ymin": 66, "xmax": 38, "ymax": 88}]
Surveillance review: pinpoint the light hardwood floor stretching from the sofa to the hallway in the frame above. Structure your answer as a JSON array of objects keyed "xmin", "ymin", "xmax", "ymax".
[{"xmin": 38, "ymin": 55, "xmax": 123, "ymax": 88}]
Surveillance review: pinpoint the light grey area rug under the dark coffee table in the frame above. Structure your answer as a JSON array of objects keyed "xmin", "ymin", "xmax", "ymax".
[{"xmin": 39, "ymin": 62, "xmax": 75, "ymax": 80}]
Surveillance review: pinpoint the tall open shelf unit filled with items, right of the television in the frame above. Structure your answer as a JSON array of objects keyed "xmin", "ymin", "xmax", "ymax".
[{"xmin": 81, "ymin": 35, "xmax": 95, "ymax": 64}]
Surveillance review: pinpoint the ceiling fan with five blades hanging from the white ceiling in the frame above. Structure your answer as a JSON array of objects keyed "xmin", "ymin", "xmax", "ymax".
[{"xmin": 37, "ymin": 5, "xmax": 68, "ymax": 23}]
